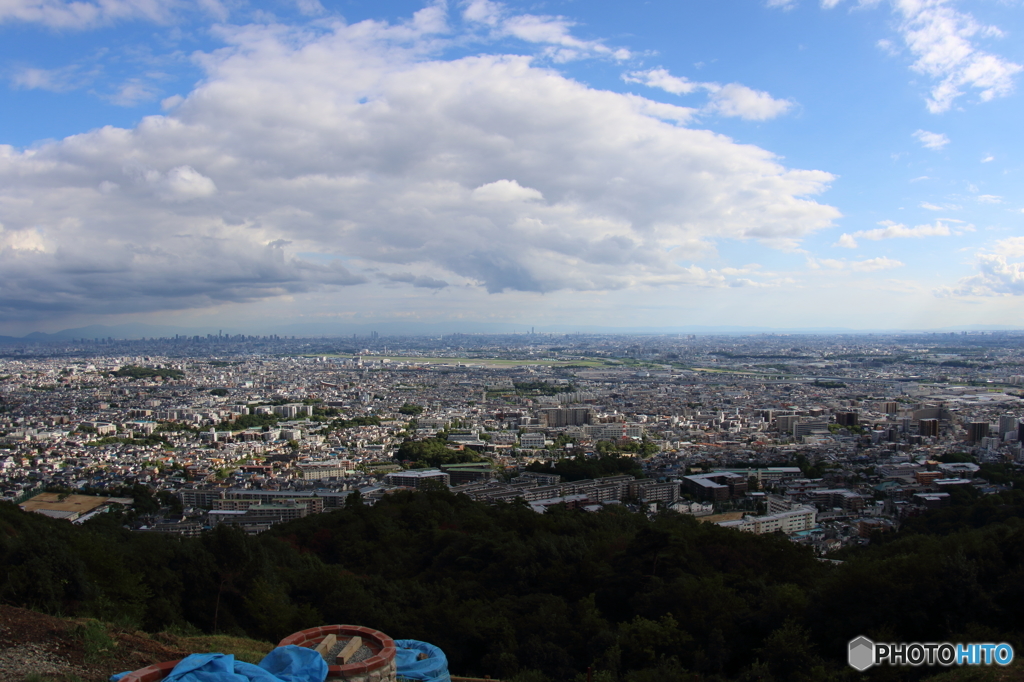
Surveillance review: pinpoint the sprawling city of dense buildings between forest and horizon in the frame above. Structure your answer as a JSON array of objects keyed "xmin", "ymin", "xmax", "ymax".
[{"xmin": 0, "ymin": 332, "xmax": 1024, "ymax": 554}]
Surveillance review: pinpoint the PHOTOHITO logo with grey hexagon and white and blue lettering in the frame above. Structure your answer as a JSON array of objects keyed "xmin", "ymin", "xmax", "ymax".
[{"xmin": 847, "ymin": 636, "xmax": 1014, "ymax": 672}]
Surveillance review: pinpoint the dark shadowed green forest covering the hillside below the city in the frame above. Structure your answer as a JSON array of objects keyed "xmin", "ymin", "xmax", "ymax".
[{"xmin": 0, "ymin": 491, "xmax": 1024, "ymax": 682}]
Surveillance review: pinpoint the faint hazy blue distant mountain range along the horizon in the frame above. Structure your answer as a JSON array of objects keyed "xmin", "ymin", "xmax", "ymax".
[{"xmin": 0, "ymin": 322, "xmax": 1024, "ymax": 345}]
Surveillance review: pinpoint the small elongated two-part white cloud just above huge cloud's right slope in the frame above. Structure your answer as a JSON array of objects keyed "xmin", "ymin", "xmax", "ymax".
[{"xmin": 623, "ymin": 68, "xmax": 793, "ymax": 121}]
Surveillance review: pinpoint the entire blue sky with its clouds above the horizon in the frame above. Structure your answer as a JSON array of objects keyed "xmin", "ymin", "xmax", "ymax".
[{"xmin": 0, "ymin": 0, "xmax": 1024, "ymax": 335}]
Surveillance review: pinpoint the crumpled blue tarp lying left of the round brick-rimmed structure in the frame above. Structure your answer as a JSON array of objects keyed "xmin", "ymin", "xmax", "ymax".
[{"xmin": 111, "ymin": 646, "xmax": 327, "ymax": 682}]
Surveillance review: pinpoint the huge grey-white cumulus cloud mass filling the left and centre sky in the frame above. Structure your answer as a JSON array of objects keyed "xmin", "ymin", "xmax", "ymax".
[{"xmin": 0, "ymin": 3, "xmax": 839, "ymax": 318}]
